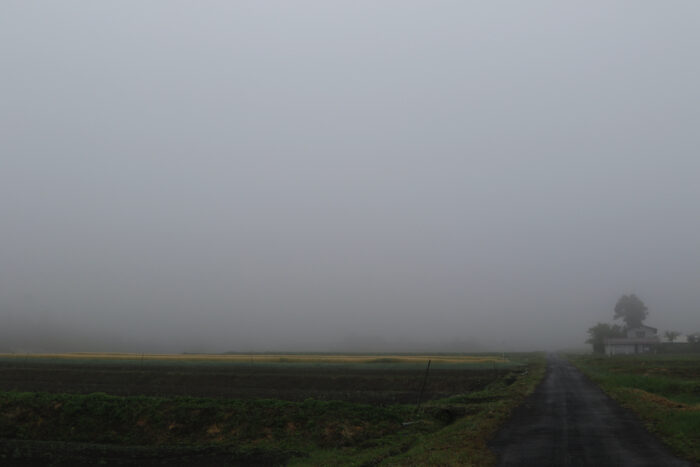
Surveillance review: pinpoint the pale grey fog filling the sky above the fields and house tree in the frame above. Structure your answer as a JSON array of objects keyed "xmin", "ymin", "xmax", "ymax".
[{"xmin": 0, "ymin": 1, "xmax": 700, "ymax": 352}]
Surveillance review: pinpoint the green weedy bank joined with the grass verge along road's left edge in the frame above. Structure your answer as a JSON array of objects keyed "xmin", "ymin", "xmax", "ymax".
[{"xmin": 0, "ymin": 354, "xmax": 545, "ymax": 465}]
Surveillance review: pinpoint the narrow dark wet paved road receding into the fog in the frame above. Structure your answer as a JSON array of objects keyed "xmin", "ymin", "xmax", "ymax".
[{"xmin": 491, "ymin": 355, "xmax": 691, "ymax": 467}]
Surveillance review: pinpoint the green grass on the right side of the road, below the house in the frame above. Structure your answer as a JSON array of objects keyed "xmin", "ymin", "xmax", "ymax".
[{"xmin": 569, "ymin": 355, "xmax": 700, "ymax": 463}]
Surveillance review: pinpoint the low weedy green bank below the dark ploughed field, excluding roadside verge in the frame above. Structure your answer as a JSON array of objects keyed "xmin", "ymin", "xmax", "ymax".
[{"xmin": 0, "ymin": 392, "xmax": 408, "ymax": 449}]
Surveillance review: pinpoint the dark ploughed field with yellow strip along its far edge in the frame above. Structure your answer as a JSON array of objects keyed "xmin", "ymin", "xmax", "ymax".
[{"xmin": 0, "ymin": 354, "xmax": 519, "ymax": 404}]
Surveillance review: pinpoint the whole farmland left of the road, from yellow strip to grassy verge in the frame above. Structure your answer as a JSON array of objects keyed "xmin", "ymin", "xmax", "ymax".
[{"xmin": 0, "ymin": 354, "xmax": 544, "ymax": 465}]
